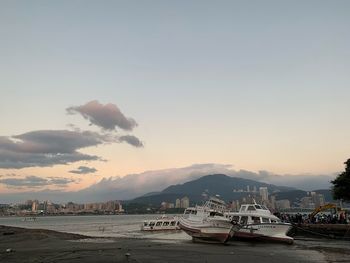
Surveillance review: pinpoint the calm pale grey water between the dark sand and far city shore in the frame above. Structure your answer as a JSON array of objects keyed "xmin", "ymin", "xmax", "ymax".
[{"xmin": 0, "ymin": 215, "xmax": 190, "ymax": 240}]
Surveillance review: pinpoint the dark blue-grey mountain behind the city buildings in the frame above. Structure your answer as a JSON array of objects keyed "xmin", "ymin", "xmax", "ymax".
[{"xmin": 132, "ymin": 174, "xmax": 294, "ymax": 205}]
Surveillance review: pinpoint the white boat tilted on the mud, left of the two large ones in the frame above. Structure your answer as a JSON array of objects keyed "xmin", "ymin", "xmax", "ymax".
[{"xmin": 180, "ymin": 197, "xmax": 239, "ymax": 243}]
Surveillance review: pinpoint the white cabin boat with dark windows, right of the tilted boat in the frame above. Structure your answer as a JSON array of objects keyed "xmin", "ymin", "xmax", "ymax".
[{"xmin": 226, "ymin": 203, "xmax": 293, "ymax": 243}]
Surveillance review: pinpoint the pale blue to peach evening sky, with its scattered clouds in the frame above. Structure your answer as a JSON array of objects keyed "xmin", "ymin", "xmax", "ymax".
[{"xmin": 0, "ymin": 0, "xmax": 350, "ymax": 198}]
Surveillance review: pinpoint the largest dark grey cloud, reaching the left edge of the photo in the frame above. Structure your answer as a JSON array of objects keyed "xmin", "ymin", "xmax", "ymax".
[{"xmin": 0, "ymin": 130, "xmax": 110, "ymax": 169}]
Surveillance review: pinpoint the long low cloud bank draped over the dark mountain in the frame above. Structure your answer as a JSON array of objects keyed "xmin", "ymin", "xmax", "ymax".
[{"xmin": 78, "ymin": 163, "xmax": 335, "ymax": 200}]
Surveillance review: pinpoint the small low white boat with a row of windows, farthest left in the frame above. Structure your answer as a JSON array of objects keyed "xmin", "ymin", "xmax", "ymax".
[{"xmin": 141, "ymin": 215, "xmax": 180, "ymax": 231}]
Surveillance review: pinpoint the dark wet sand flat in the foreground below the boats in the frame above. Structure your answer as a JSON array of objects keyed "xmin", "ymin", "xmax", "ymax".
[{"xmin": 0, "ymin": 226, "xmax": 350, "ymax": 263}]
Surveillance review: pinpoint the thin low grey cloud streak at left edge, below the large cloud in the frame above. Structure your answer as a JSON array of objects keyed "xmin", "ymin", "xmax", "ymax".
[{"xmin": 0, "ymin": 175, "xmax": 75, "ymax": 188}]
